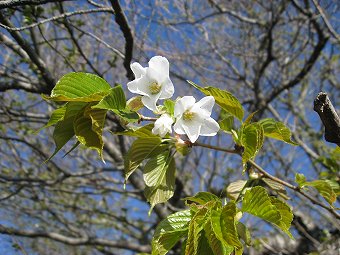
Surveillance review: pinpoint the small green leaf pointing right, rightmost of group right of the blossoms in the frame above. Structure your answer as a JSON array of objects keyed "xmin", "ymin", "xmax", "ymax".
[{"xmin": 258, "ymin": 118, "xmax": 299, "ymax": 145}]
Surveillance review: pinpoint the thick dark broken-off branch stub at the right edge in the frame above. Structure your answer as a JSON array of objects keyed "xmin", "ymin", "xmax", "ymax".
[{"xmin": 314, "ymin": 92, "xmax": 340, "ymax": 147}]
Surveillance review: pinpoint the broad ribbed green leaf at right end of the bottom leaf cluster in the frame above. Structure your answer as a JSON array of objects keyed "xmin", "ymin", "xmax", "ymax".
[{"xmin": 242, "ymin": 186, "xmax": 293, "ymax": 238}]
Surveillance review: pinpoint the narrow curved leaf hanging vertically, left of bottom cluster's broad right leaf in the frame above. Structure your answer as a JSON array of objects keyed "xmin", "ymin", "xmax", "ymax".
[{"xmin": 220, "ymin": 202, "xmax": 243, "ymax": 250}]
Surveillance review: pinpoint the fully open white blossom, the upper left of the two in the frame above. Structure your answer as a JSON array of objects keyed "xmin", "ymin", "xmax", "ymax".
[{"xmin": 127, "ymin": 56, "xmax": 174, "ymax": 111}]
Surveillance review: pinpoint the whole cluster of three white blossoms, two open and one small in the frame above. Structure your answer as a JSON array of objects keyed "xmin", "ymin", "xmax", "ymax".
[{"xmin": 127, "ymin": 56, "xmax": 220, "ymax": 143}]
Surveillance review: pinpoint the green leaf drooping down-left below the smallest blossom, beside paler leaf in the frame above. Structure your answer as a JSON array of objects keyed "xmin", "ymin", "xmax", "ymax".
[{"xmin": 124, "ymin": 137, "xmax": 162, "ymax": 181}]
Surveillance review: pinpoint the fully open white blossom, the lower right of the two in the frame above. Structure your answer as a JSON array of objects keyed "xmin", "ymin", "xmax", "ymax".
[{"xmin": 174, "ymin": 96, "xmax": 220, "ymax": 143}]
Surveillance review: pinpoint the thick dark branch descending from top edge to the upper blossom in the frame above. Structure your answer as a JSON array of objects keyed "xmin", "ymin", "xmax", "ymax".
[{"xmin": 110, "ymin": 0, "xmax": 134, "ymax": 80}]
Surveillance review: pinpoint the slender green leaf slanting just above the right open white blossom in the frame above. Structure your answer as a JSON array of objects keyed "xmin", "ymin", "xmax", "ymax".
[{"xmin": 188, "ymin": 81, "xmax": 244, "ymax": 121}]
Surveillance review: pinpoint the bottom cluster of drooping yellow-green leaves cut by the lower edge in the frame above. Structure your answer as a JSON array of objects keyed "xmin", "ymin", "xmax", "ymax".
[{"xmin": 152, "ymin": 186, "xmax": 293, "ymax": 255}]
